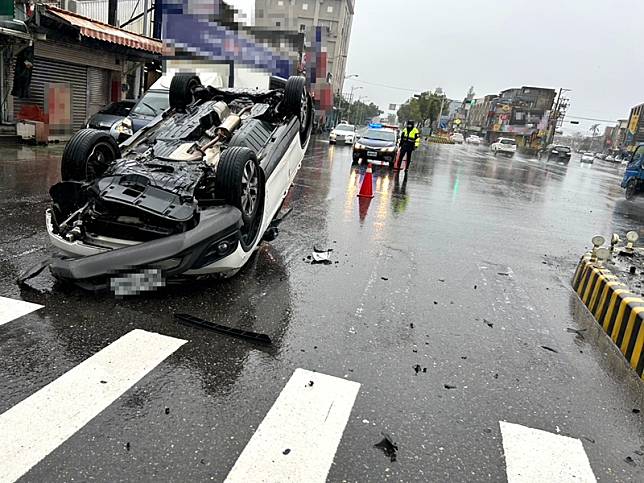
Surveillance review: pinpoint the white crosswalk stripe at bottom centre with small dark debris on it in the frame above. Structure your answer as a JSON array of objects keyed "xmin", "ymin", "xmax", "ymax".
[{"xmin": 226, "ymin": 369, "xmax": 360, "ymax": 483}]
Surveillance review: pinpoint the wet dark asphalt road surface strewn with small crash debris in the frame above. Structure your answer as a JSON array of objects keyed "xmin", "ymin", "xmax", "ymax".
[{"xmin": 0, "ymin": 140, "xmax": 644, "ymax": 482}]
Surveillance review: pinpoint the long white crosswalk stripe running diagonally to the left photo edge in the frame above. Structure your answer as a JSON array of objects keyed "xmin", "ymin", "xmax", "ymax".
[{"xmin": 0, "ymin": 329, "xmax": 187, "ymax": 483}]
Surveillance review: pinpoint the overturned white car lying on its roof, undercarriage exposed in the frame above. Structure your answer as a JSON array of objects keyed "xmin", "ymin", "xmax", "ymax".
[{"xmin": 46, "ymin": 74, "xmax": 312, "ymax": 293}]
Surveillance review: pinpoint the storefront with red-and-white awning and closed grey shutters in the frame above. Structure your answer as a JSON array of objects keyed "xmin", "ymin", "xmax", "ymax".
[{"xmin": 12, "ymin": 5, "xmax": 163, "ymax": 139}]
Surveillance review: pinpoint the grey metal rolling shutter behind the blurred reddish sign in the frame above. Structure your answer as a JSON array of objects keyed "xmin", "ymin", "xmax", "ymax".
[{"xmin": 14, "ymin": 57, "xmax": 87, "ymax": 131}]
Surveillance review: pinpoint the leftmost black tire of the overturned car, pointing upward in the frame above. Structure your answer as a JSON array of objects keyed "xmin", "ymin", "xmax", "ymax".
[{"xmin": 60, "ymin": 129, "xmax": 121, "ymax": 181}]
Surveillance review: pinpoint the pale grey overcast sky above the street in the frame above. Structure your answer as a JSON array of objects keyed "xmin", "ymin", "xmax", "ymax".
[{"xmin": 231, "ymin": 0, "xmax": 644, "ymax": 131}]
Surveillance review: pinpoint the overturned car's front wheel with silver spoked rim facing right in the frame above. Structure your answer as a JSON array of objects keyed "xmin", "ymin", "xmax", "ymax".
[{"xmin": 215, "ymin": 147, "xmax": 264, "ymax": 251}]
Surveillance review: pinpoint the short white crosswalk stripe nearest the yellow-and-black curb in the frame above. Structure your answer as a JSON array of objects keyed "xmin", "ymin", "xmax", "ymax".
[{"xmin": 499, "ymin": 421, "xmax": 597, "ymax": 483}]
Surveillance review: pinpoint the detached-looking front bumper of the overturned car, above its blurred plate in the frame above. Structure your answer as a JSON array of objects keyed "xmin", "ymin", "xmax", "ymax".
[{"xmin": 45, "ymin": 206, "xmax": 250, "ymax": 285}]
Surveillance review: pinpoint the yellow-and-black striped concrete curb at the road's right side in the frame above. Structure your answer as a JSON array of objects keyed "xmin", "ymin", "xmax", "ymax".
[{"xmin": 572, "ymin": 253, "xmax": 644, "ymax": 380}]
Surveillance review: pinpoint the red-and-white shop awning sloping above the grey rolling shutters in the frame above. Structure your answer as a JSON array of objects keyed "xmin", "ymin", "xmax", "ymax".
[{"xmin": 45, "ymin": 5, "xmax": 163, "ymax": 54}]
